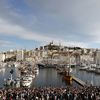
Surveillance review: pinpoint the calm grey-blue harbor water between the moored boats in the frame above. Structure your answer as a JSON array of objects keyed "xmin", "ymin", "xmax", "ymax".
[{"xmin": 0, "ymin": 67, "xmax": 100, "ymax": 87}]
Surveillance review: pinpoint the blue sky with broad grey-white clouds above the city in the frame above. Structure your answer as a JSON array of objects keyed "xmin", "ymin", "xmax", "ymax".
[{"xmin": 0, "ymin": 0, "xmax": 100, "ymax": 51}]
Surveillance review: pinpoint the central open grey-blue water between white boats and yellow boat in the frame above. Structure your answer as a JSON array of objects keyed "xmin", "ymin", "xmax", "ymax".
[{"xmin": 32, "ymin": 68, "xmax": 66, "ymax": 87}]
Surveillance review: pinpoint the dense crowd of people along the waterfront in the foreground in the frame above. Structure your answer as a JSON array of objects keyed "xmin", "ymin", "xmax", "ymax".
[{"xmin": 0, "ymin": 86, "xmax": 100, "ymax": 100}]
